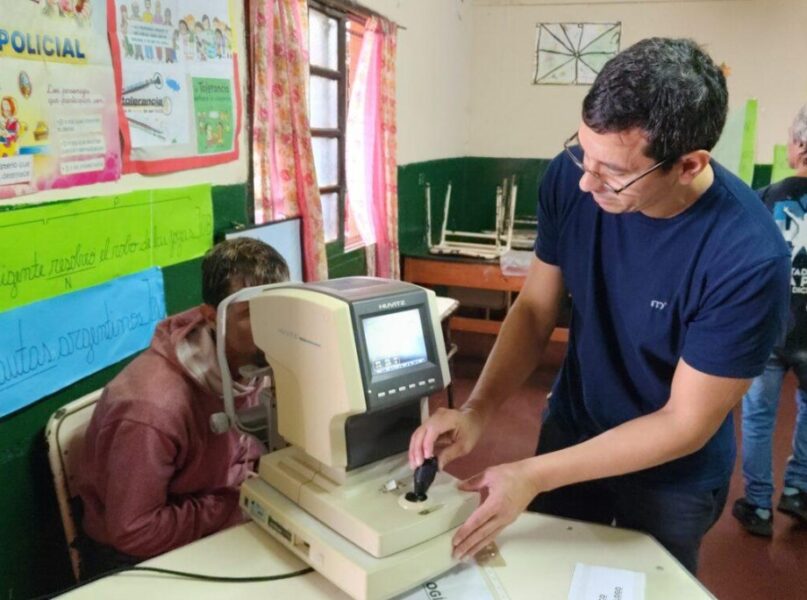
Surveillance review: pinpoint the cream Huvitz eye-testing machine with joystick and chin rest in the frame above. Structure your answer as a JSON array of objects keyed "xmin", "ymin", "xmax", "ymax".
[{"xmin": 214, "ymin": 277, "xmax": 478, "ymax": 600}]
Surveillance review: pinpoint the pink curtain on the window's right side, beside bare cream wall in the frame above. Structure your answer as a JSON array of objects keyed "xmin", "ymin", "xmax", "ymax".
[{"xmin": 346, "ymin": 17, "xmax": 400, "ymax": 279}]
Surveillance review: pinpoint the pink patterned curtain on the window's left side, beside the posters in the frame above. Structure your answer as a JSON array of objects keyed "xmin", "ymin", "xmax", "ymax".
[{"xmin": 249, "ymin": 0, "xmax": 328, "ymax": 281}]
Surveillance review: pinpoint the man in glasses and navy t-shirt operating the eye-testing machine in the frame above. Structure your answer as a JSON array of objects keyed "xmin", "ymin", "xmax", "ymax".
[{"xmin": 409, "ymin": 38, "xmax": 790, "ymax": 573}]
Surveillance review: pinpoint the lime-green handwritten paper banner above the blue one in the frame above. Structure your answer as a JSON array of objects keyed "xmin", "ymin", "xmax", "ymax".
[{"xmin": 0, "ymin": 185, "xmax": 213, "ymax": 310}]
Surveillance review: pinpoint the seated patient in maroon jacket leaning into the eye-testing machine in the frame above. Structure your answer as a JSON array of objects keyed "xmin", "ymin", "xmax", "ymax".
[{"xmin": 78, "ymin": 238, "xmax": 289, "ymax": 576}]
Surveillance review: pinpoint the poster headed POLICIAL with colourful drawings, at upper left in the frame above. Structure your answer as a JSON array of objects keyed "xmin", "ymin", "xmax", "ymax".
[{"xmin": 0, "ymin": 0, "xmax": 121, "ymax": 199}]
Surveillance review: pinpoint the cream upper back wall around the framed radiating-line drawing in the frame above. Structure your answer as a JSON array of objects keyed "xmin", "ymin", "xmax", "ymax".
[{"xmin": 468, "ymin": 0, "xmax": 807, "ymax": 162}]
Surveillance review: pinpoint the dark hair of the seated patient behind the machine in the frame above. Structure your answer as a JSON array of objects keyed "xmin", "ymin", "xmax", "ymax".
[{"xmin": 202, "ymin": 238, "xmax": 289, "ymax": 307}]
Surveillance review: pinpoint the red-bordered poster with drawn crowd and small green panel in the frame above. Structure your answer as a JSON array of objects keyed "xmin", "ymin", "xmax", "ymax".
[{"xmin": 108, "ymin": 0, "xmax": 241, "ymax": 173}]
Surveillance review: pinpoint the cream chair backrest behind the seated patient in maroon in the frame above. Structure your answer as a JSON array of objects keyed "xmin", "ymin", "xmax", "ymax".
[{"xmin": 45, "ymin": 390, "xmax": 102, "ymax": 581}]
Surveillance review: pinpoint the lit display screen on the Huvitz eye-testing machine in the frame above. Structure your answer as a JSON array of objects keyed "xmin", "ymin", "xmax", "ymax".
[{"xmin": 363, "ymin": 309, "xmax": 428, "ymax": 376}]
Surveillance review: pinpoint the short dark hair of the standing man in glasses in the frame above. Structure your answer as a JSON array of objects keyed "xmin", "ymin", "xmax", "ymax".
[{"xmin": 583, "ymin": 38, "xmax": 728, "ymax": 168}]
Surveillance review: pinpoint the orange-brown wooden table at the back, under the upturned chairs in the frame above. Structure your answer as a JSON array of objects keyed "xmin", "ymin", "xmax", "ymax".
[{"xmin": 403, "ymin": 256, "xmax": 569, "ymax": 342}]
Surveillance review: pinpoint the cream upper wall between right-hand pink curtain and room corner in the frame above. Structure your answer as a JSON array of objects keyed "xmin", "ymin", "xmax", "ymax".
[{"xmin": 361, "ymin": 0, "xmax": 473, "ymax": 164}]
